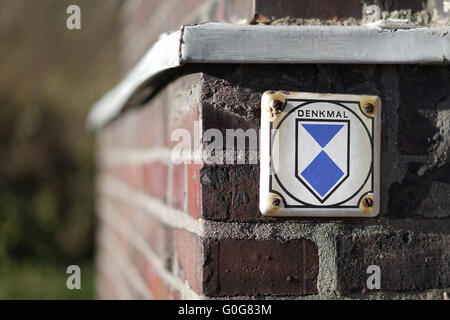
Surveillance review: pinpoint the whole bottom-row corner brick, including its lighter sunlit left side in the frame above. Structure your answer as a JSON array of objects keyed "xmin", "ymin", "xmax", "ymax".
[{"xmin": 174, "ymin": 230, "xmax": 319, "ymax": 296}]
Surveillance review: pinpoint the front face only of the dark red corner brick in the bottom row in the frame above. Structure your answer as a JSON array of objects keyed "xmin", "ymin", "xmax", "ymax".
[{"xmin": 218, "ymin": 239, "xmax": 319, "ymax": 296}]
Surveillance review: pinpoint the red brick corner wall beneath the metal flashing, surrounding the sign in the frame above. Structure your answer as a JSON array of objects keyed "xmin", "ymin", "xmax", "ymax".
[{"xmin": 93, "ymin": 0, "xmax": 450, "ymax": 299}]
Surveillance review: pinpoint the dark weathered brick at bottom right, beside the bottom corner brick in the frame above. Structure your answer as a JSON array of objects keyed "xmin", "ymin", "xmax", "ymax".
[{"xmin": 337, "ymin": 231, "xmax": 450, "ymax": 295}]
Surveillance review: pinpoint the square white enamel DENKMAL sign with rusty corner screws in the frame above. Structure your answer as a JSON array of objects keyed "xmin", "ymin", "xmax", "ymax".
[{"xmin": 259, "ymin": 91, "xmax": 381, "ymax": 217}]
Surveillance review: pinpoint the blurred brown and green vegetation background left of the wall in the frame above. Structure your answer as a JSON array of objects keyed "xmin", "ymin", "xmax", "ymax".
[{"xmin": 0, "ymin": 0, "xmax": 120, "ymax": 299}]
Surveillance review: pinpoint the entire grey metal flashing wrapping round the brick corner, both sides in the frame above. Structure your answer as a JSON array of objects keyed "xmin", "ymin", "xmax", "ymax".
[{"xmin": 88, "ymin": 23, "xmax": 450, "ymax": 129}]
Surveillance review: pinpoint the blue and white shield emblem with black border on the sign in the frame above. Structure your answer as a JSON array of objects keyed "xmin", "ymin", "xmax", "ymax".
[{"xmin": 295, "ymin": 119, "xmax": 350, "ymax": 203}]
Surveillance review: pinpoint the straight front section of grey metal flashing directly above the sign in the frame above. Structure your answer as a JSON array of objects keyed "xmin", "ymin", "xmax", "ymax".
[{"xmin": 181, "ymin": 24, "xmax": 450, "ymax": 64}]
